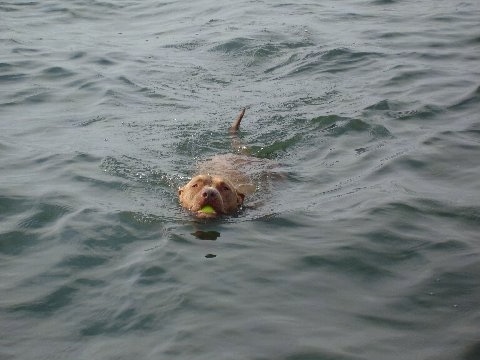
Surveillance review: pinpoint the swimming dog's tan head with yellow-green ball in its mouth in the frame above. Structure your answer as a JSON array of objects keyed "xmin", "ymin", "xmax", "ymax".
[{"xmin": 178, "ymin": 175, "xmax": 244, "ymax": 218}]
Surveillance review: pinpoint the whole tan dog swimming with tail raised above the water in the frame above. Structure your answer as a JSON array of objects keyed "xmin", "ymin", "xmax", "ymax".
[{"xmin": 178, "ymin": 109, "xmax": 255, "ymax": 218}]
